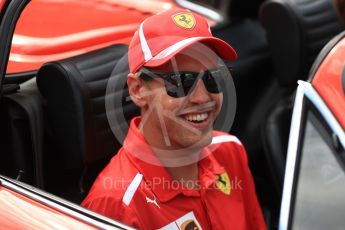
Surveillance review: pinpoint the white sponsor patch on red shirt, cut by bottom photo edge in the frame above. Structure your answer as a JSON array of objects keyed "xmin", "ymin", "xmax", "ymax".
[{"xmin": 160, "ymin": 211, "xmax": 202, "ymax": 230}]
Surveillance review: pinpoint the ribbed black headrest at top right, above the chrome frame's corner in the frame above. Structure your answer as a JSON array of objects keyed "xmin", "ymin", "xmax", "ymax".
[{"xmin": 259, "ymin": 0, "xmax": 344, "ymax": 89}]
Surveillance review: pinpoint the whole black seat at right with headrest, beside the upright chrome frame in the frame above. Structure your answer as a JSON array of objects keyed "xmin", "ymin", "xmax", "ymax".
[{"xmin": 259, "ymin": 0, "xmax": 344, "ymax": 203}]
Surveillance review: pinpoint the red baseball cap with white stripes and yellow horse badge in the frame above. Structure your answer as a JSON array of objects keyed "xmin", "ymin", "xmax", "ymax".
[{"xmin": 128, "ymin": 9, "xmax": 237, "ymax": 73}]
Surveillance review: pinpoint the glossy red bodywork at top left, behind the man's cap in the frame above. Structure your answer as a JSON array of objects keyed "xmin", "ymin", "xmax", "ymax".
[{"xmin": 7, "ymin": 0, "xmax": 214, "ymax": 73}]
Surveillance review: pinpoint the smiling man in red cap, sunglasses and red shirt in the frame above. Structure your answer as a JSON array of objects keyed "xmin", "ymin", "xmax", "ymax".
[{"xmin": 82, "ymin": 10, "xmax": 265, "ymax": 229}]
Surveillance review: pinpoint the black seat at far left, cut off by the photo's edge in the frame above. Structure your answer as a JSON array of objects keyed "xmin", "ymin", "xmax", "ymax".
[{"xmin": 0, "ymin": 77, "xmax": 44, "ymax": 189}]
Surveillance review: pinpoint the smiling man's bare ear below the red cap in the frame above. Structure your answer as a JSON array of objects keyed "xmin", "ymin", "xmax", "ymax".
[{"xmin": 127, "ymin": 73, "xmax": 147, "ymax": 108}]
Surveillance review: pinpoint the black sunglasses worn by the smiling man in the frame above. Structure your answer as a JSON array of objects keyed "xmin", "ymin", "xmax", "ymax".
[{"xmin": 139, "ymin": 66, "xmax": 231, "ymax": 98}]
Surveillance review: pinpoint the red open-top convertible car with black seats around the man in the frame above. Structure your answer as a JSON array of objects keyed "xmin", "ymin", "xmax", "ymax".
[{"xmin": 0, "ymin": 0, "xmax": 345, "ymax": 230}]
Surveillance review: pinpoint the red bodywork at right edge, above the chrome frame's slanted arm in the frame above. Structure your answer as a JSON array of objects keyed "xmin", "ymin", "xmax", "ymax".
[{"xmin": 312, "ymin": 38, "xmax": 345, "ymax": 129}]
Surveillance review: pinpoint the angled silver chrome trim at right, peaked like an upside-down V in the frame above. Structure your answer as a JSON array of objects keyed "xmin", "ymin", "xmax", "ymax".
[{"xmin": 279, "ymin": 81, "xmax": 345, "ymax": 230}]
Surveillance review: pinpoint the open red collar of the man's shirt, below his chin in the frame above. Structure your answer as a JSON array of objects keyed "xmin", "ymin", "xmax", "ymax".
[{"xmin": 123, "ymin": 117, "xmax": 225, "ymax": 202}]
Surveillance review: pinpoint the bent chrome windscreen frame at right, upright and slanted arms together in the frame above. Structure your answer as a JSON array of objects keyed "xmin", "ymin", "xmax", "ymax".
[{"xmin": 279, "ymin": 81, "xmax": 345, "ymax": 230}]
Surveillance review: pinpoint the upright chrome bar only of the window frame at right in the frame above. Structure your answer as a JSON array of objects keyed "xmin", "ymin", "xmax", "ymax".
[{"xmin": 279, "ymin": 82, "xmax": 304, "ymax": 230}]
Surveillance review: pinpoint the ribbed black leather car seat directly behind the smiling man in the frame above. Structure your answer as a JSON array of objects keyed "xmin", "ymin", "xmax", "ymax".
[{"xmin": 37, "ymin": 45, "xmax": 138, "ymax": 202}]
